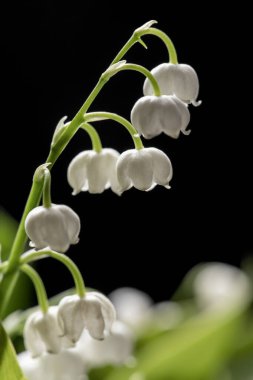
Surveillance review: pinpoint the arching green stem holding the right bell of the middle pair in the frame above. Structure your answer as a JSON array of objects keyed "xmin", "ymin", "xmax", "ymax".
[{"xmin": 84, "ymin": 112, "xmax": 144, "ymax": 150}]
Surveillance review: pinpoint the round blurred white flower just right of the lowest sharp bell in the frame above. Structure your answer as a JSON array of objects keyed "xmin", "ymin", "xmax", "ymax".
[{"xmin": 109, "ymin": 288, "xmax": 153, "ymax": 328}]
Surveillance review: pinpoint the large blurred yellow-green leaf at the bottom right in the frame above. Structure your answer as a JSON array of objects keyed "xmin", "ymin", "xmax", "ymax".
[{"xmin": 105, "ymin": 310, "xmax": 247, "ymax": 380}]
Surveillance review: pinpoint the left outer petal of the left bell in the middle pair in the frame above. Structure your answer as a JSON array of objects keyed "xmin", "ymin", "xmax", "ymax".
[{"xmin": 67, "ymin": 150, "xmax": 96, "ymax": 195}]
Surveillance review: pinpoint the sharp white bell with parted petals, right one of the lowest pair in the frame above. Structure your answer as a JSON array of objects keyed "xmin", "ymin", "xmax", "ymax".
[{"xmin": 58, "ymin": 292, "xmax": 116, "ymax": 343}]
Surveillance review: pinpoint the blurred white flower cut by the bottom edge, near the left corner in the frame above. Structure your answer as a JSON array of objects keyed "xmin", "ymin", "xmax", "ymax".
[{"xmin": 18, "ymin": 350, "xmax": 87, "ymax": 380}]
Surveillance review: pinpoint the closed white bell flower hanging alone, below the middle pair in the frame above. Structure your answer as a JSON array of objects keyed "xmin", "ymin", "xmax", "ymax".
[{"xmin": 25, "ymin": 204, "xmax": 80, "ymax": 252}]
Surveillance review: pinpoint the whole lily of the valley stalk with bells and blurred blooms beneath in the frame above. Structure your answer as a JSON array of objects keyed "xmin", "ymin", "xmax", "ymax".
[{"xmin": 0, "ymin": 21, "xmax": 199, "ymax": 380}]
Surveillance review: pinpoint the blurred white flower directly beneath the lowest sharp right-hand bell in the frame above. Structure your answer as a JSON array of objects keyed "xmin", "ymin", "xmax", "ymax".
[{"xmin": 76, "ymin": 321, "xmax": 134, "ymax": 367}]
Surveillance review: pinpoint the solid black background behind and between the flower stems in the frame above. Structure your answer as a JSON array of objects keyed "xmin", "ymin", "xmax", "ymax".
[{"xmin": 0, "ymin": 1, "xmax": 253, "ymax": 300}]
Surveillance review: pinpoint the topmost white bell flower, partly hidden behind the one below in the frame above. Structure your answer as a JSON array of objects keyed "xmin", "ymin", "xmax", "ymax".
[{"xmin": 143, "ymin": 63, "xmax": 201, "ymax": 106}]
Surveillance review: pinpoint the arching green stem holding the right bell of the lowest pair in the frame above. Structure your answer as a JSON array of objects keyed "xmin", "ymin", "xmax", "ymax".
[{"xmin": 20, "ymin": 249, "xmax": 86, "ymax": 298}]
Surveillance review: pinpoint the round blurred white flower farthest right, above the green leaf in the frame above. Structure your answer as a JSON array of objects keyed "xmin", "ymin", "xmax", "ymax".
[{"xmin": 193, "ymin": 263, "xmax": 251, "ymax": 311}]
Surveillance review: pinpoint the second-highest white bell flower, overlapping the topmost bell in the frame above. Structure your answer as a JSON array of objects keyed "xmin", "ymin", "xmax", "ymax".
[{"xmin": 131, "ymin": 95, "xmax": 190, "ymax": 139}]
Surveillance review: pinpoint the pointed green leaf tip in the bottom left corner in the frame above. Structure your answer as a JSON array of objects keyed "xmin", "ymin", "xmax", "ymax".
[{"xmin": 0, "ymin": 324, "xmax": 26, "ymax": 380}]
